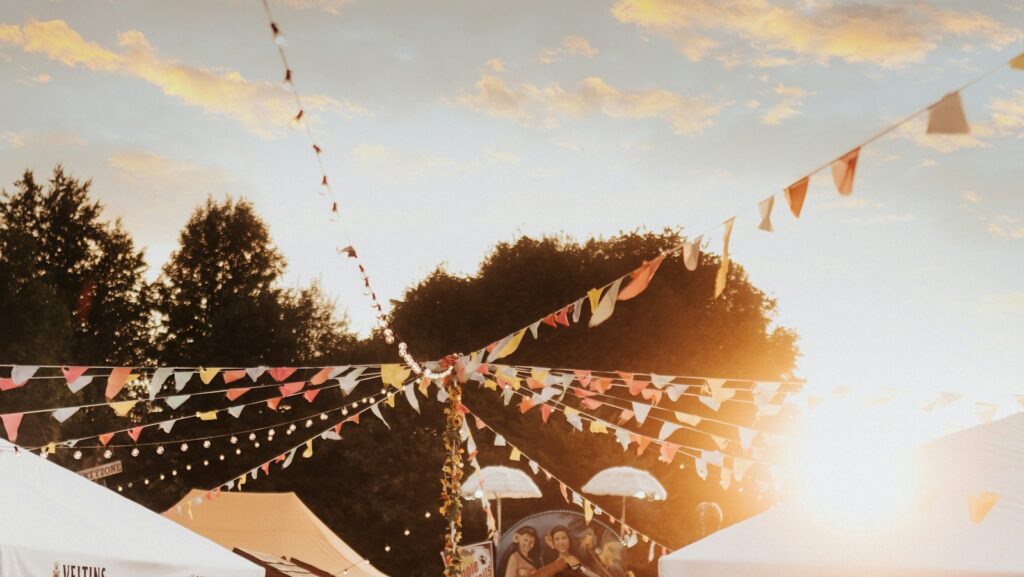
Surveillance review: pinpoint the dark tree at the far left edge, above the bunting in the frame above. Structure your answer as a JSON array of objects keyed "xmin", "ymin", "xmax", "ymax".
[{"xmin": 0, "ymin": 166, "xmax": 152, "ymax": 365}]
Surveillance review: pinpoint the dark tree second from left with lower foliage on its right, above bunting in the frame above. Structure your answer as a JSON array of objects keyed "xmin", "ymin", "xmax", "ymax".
[{"xmin": 159, "ymin": 199, "xmax": 354, "ymax": 366}]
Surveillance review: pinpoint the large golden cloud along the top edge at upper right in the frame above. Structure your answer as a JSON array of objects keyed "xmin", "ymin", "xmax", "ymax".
[{"xmin": 611, "ymin": 0, "xmax": 1021, "ymax": 69}]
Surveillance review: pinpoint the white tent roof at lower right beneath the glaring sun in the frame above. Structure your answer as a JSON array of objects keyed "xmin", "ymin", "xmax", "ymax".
[{"xmin": 658, "ymin": 414, "xmax": 1024, "ymax": 577}]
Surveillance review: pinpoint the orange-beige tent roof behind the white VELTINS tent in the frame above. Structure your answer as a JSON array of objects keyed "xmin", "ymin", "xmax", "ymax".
[{"xmin": 168, "ymin": 491, "xmax": 386, "ymax": 577}]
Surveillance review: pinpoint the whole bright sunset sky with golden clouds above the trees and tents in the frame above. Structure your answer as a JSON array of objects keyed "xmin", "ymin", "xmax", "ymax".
[{"xmin": 0, "ymin": 0, "xmax": 1024, "ymax": 409}]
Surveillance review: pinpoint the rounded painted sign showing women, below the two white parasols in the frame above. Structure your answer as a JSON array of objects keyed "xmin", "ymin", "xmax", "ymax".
[{"xmin": 496, "ymin": 509, "xmax": 627, "ymax": 577}]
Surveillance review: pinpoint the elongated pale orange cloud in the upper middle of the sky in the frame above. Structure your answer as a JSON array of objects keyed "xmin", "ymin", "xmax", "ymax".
[{"xmin": 456, "ymin": 74, "xmax": 727, "ymax": 134}]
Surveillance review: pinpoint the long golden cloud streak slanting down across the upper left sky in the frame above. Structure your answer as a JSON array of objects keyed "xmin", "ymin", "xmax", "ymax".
[{"xmin": 0, "ymin": 20, "xmax": 366, "ymax": 137}]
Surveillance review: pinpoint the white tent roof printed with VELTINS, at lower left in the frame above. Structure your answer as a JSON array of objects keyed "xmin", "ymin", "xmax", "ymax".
[{"xmin": 0, "ymin": 441, "xmax": 264, "ymax": 577}]
